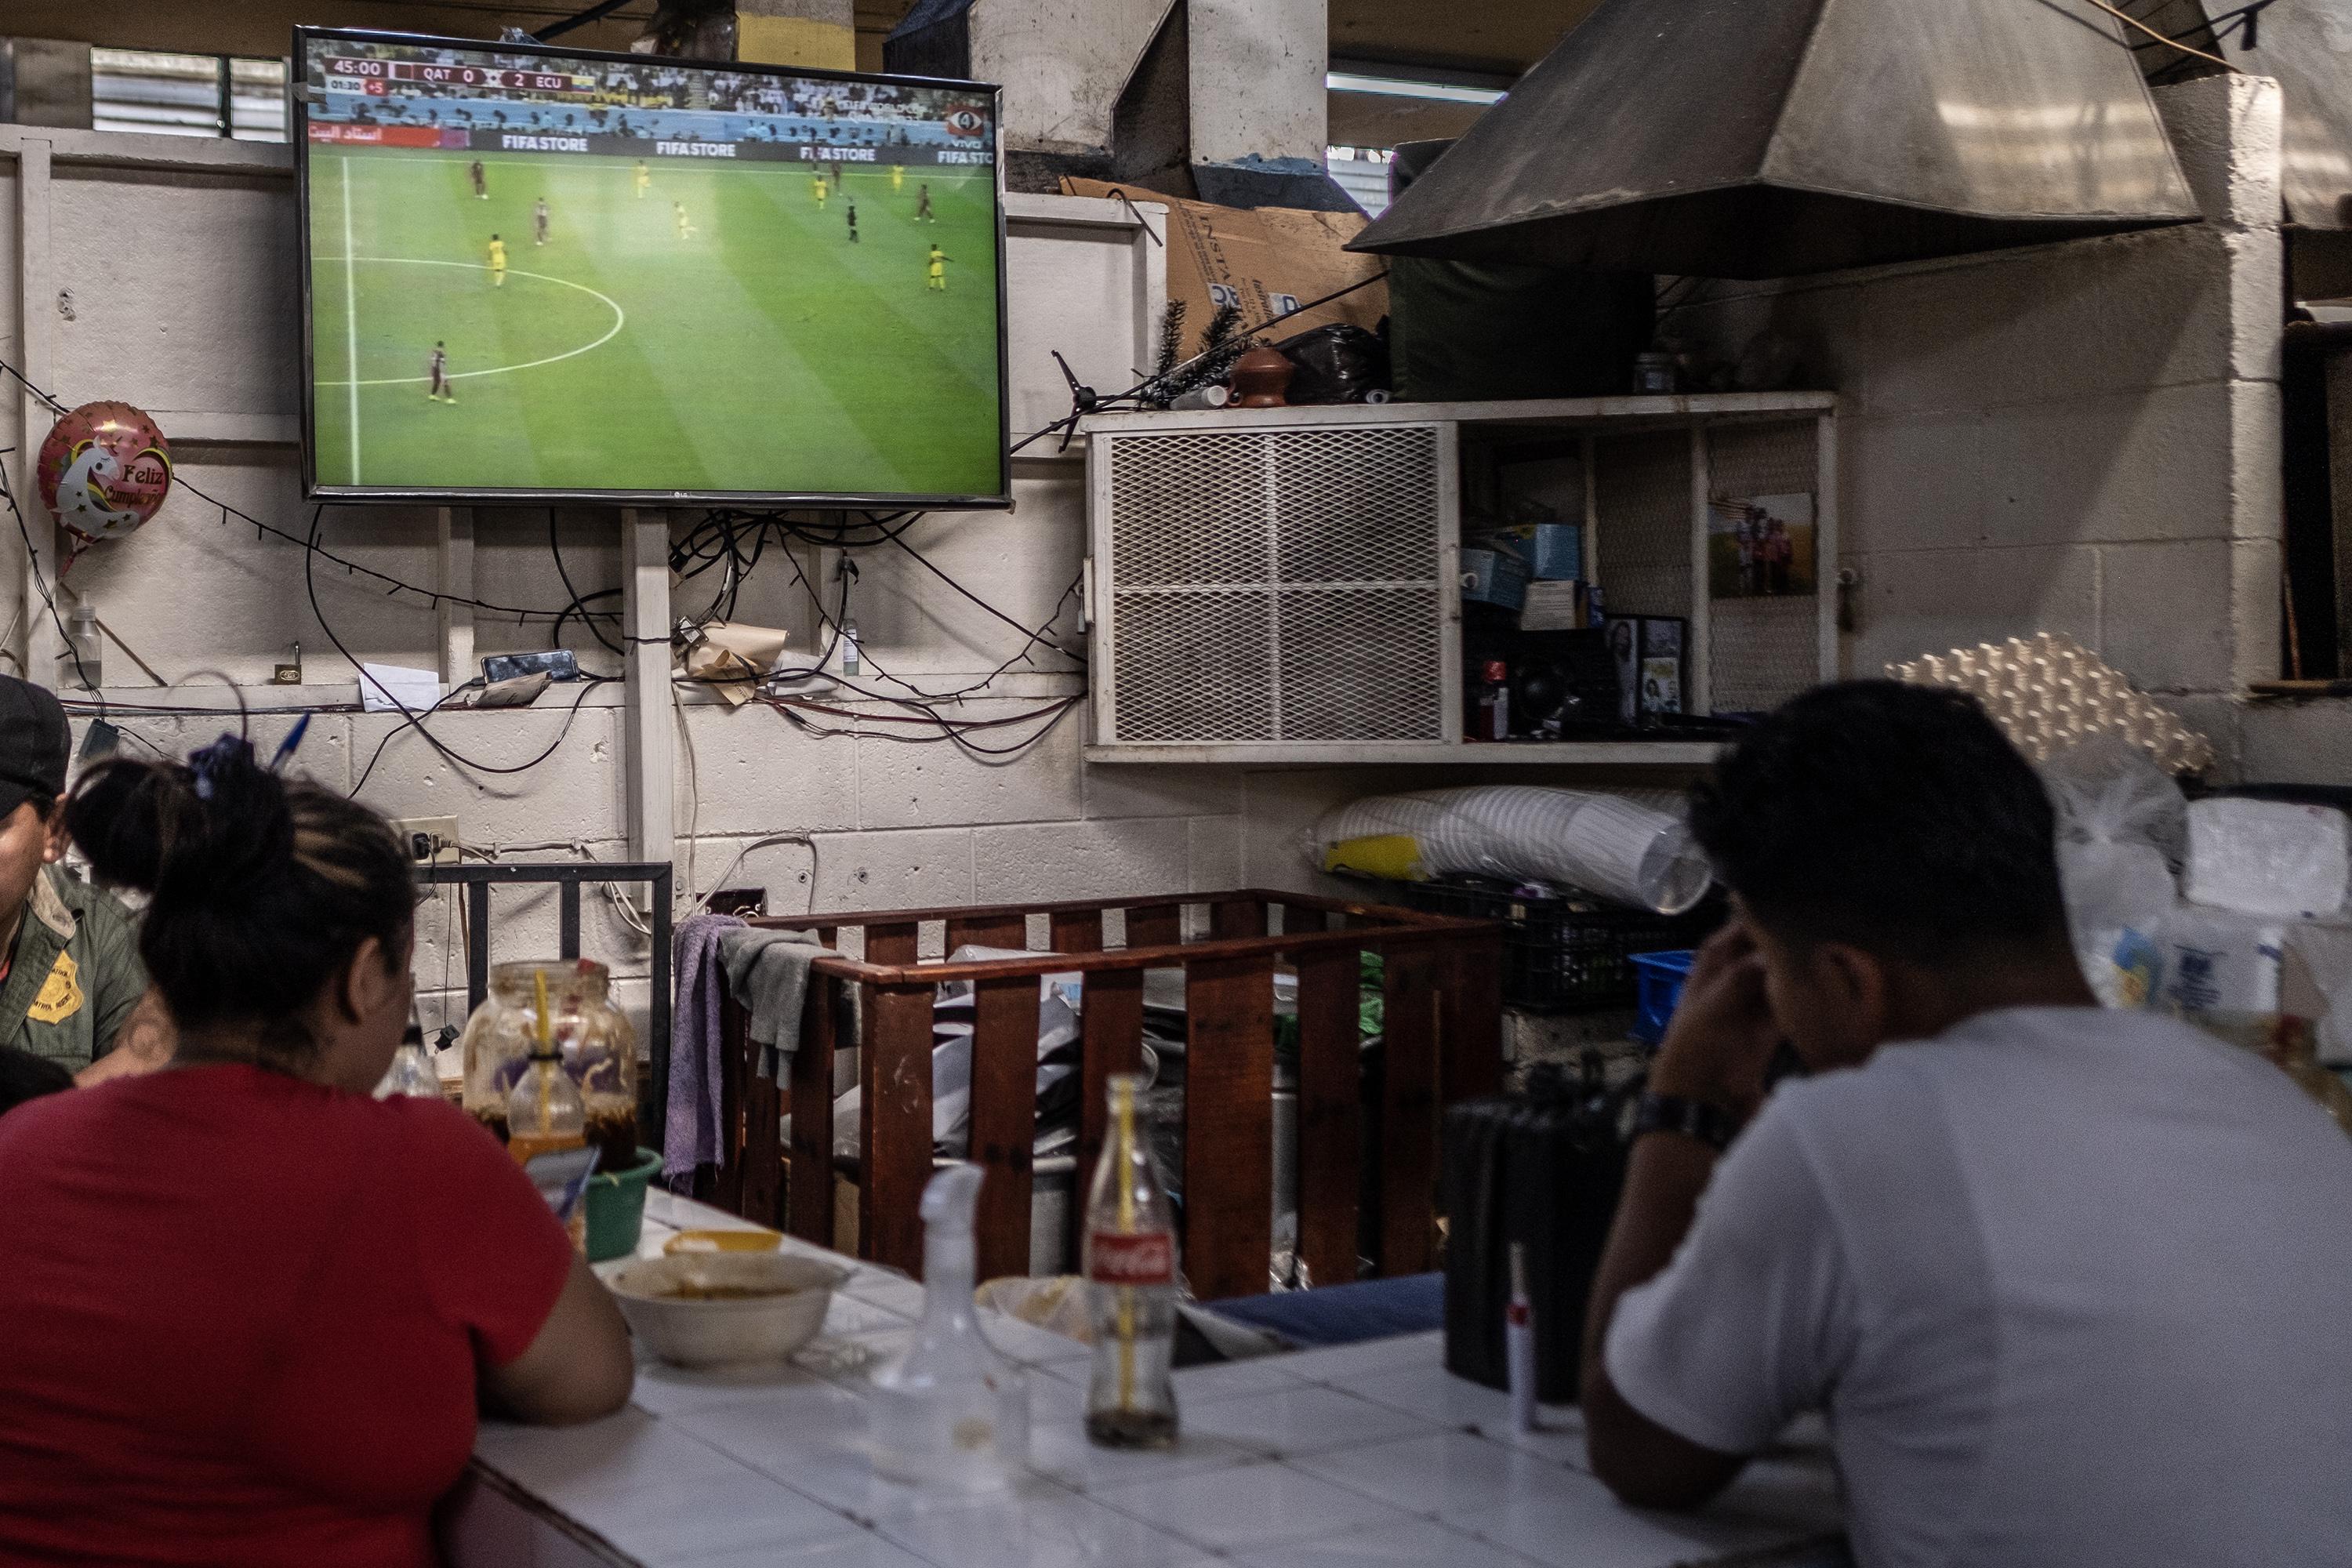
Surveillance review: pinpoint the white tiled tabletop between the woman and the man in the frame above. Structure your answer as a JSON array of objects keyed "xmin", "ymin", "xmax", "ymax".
[{"xmin": 447, "ymin": 1194, "xmax": 1839, "ymax": 1568}]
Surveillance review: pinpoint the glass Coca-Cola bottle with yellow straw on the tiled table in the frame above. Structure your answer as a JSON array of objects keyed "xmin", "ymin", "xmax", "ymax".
[{"xmin": 1087, "ymin": 1074, "xmax": 1176, "ymax": 1448}]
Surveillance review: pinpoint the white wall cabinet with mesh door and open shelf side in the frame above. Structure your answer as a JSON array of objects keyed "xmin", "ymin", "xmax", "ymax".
[{"xmin": 1082, "ymin": 393, "xmax": 1837, "ymax": 767}]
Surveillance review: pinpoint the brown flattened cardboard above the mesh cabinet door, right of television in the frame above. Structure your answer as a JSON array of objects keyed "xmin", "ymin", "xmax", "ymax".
[{"xmin": 1061, "ymin": 176, "xmax": 1388, "ymax": 355}]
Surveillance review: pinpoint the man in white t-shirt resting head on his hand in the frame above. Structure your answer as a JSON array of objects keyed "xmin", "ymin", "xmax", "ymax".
[{"xmin": 1583, "ymin": 682, "xmax": 2352, "ymax": 1568}]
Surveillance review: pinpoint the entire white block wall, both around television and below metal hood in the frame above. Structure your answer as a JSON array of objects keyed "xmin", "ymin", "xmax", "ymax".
[{"xmin": 0, "ymin": 78, "xmax": 2314, "ymax": 1053}]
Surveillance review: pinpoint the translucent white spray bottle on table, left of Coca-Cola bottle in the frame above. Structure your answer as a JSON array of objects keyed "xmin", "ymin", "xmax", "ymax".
[{"xmin": 870, "ymin": 1163, "xmax": 1028, "ymax": 1493}]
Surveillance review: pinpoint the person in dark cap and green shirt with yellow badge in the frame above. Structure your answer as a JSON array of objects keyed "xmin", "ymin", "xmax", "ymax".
[{"xmin": 0, "ymin": 675, "xmax": 172, "ymax": 1083}]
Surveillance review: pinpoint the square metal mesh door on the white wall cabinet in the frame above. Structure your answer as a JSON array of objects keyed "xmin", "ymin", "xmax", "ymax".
[{"xmin": 1094, "ymin": 423, "xmax": 1451, "ymax": 746}]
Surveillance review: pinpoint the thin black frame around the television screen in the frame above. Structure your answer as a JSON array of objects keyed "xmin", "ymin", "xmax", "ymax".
[{"xmin": 287, "ymin": 26, "xmax": 1014, "ymax": 513}]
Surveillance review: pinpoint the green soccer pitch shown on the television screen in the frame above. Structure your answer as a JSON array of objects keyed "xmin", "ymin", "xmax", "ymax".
[{"xmin": 310, "ymin": 148, "xmax": 1002, "ymax": 496}]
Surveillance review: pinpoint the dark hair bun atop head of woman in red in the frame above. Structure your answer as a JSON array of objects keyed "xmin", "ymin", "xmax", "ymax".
[{"xmin": 66, "ymin": 736, "xmax": 294, "ymax": 902}]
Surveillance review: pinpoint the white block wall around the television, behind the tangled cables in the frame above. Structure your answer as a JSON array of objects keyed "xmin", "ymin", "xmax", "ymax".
[{"xmin": 0, "ymin": 127, "xmax": 1244, "ymax": 1048}]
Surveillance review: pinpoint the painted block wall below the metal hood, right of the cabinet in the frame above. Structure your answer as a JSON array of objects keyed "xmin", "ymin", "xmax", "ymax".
[{"xmin": 1670, "ymin": 75, "xmax": 2284, "ymax": 771}]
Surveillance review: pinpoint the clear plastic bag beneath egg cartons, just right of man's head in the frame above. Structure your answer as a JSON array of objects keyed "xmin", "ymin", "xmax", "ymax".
[{"xmin": 2042, "ymin": 739, "xmax": 2187, "ymax": 1006}]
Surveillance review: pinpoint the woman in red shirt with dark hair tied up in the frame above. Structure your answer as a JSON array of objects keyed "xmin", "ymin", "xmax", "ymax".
[{"xmin": 0, "ymin": 736, "xmax": 630, "ymax": 1568}]
